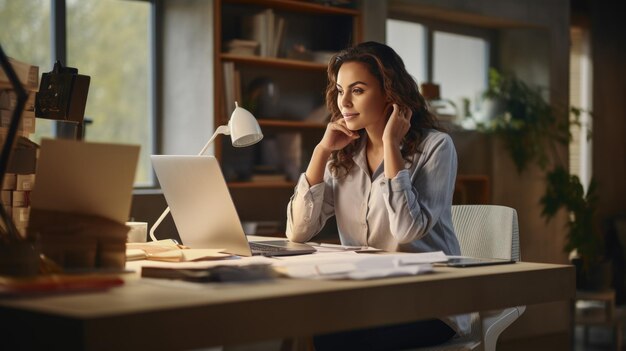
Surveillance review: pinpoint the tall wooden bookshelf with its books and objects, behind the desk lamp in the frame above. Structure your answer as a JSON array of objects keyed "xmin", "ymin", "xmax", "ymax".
[{"xmin": 213, "ymin": 0, "xmax": 361, "ymax": 231}]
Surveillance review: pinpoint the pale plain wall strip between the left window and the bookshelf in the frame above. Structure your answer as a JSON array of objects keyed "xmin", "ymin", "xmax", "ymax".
[{"xmin": 159, "ymin": 0, "xmax": 213, "ymax": 155}]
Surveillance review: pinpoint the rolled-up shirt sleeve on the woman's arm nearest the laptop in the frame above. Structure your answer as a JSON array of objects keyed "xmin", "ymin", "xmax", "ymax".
[{"xmin": 286, "ymin": 172, "xmax": 335, "ymax": 242}]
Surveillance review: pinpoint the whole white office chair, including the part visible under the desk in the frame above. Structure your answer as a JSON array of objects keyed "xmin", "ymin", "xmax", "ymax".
[{"xmin": 419, "ymin": 205, "xmax": 526, "ymax": 351}]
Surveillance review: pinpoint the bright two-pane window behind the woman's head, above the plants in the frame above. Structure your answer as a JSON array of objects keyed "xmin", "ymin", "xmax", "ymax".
[{"xmin": 387, "ymin": 19, "xmax": 492, "ymax": 122}]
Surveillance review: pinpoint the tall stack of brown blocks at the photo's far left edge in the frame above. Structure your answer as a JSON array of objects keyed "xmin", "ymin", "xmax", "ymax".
[{"xmin": 0, "ymin": 58, "xmax": 39, "ymax": 235}]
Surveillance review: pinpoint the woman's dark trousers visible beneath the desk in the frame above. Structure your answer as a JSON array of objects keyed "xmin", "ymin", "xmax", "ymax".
[{"xmin": 313, "ymin": 319, "xmax": 455, "ymax": 351}]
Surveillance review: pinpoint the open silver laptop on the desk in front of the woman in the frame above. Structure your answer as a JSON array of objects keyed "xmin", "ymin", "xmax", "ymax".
[{"xmin": 150, "ymin": 155, "xmax": 316, "ymax": 256}]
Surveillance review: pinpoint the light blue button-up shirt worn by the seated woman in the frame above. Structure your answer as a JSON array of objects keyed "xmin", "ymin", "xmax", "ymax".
[{"xmin": 287, "ymin": 131, "xmax": 461, "ymax": 255}]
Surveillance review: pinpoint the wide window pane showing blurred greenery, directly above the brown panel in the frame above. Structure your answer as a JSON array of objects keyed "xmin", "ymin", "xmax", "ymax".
[{"xmin": 67, "ymin": 0, "xmax": 153, "ymax": 186}]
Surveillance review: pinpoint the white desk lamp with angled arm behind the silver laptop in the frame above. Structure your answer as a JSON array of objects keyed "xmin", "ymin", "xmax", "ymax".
[{"xmin": 150, "ymin": 102, "xmax": 263, "ymax": 241}]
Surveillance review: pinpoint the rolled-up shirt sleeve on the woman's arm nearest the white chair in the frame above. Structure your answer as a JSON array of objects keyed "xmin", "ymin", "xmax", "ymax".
[{"xmin": 379, "ymin": 136, "xmax": 457, "ymax": 243}]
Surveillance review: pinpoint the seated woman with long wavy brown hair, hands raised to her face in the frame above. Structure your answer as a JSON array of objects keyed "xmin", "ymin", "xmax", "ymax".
[{"xmin": 287, "ymin": 42, "xmax": 469, "ymax": 349}]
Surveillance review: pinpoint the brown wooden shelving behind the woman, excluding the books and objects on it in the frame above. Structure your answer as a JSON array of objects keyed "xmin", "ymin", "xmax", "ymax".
[{"xmin": 213, "ymin": 0, "xmax": 361, "ymax": 221}]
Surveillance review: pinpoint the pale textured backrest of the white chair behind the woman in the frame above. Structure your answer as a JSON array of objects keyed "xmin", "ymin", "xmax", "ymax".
[{"xmin": 452, "ymin": 205, "xmax": 521, "ymax": 261}]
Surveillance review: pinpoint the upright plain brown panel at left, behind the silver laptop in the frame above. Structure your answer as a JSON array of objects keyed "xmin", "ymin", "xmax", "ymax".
[{"xmin": 30, "ymin": 139, "xmax": 139, "ymax": 223}]
